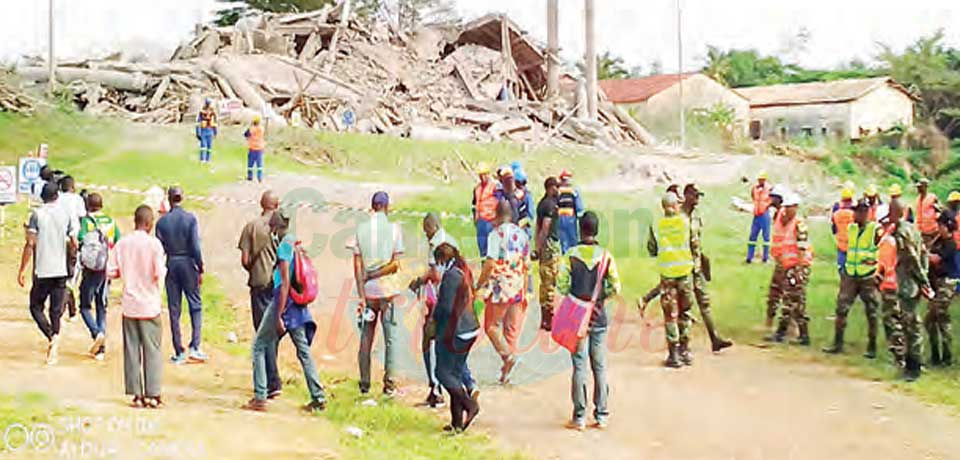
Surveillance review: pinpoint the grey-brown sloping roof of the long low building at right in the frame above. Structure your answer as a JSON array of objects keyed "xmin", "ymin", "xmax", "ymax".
[{"xmin": 737, "ymin": 77, "xmax": 917, "ymax": 107}]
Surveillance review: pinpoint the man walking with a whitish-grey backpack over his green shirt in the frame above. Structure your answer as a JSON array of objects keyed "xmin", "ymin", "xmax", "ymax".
[{"xmin": 78, "ymin": 193, "xmax": 121, "ymax": 361}]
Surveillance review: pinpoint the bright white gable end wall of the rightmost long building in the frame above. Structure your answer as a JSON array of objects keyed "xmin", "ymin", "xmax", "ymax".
[{"xmin": 850, "ymin": 86, "xmax": 914, "ymax": 139}]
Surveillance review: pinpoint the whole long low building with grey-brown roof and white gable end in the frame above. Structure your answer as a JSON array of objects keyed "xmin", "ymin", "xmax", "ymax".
[{"xmin": 737, "ymin": 77, "xmax": 919, "ymax": 140}]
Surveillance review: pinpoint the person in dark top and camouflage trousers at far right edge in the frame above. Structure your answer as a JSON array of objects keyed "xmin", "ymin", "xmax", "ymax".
[{"xmin": 923, "ymin": 211, "xmax": 960, "ymax": 366}]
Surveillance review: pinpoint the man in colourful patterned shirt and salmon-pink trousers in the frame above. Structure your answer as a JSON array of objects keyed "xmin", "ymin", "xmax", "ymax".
[{"xmin": 477, "ymin": 200, "xmax": 530, "ymax": 384}]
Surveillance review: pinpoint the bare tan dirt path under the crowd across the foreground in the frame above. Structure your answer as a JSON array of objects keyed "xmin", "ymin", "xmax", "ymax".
[{"xmin": 0, "ymin": 170, "xmax": 960, "ymax": 460}]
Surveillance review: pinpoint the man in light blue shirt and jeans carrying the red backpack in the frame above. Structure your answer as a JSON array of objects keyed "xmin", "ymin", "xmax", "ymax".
[{"xmin": 244, "ymin": 209, "xmax": 327, "ymax": 412}]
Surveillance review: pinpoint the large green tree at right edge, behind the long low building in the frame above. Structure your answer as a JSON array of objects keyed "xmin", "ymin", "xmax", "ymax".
[{"xmin": 879, "ymin": 30, "xmax": 960, "ymax": 137}]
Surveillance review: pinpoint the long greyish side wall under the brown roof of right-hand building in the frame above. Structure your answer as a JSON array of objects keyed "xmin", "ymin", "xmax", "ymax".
[{"xmin": 752, "ymin": 103, "xmax": 851, "ymax": 139}]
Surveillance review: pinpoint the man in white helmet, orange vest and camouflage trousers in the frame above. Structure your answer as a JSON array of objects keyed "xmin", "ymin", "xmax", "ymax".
[{"xmin": 766, "ymin": 194, "xmax": 813, "ymax": 346}]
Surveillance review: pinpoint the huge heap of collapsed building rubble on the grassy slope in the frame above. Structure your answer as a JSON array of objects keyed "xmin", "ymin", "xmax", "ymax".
[{"xmin": 17, "ymin": 4, "xmax": 653, "ymax": 146}]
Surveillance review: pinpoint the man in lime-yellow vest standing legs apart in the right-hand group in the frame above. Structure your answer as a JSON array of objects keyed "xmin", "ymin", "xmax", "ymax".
[{"xmin": 823, "ymin": 200, "xmax": 883, "ymax": 359}]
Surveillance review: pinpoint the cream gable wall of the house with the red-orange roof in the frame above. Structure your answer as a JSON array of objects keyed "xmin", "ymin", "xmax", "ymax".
[{"xmin": 621, "ymin": 74, "xmax": 750, "ymax": 133}]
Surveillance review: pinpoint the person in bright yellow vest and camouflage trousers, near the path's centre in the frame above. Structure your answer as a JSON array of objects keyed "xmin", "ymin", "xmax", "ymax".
[{"xmin": 647, "ymin": 193, "xmax": 693, "ymax": 368}]
